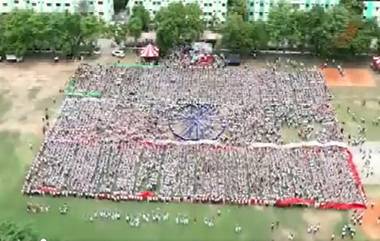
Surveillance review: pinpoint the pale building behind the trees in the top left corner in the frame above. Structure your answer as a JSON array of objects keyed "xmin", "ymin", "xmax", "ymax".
[{"xmin": 0, "ymin": 0, "xmax": 114, "ymax": 21}]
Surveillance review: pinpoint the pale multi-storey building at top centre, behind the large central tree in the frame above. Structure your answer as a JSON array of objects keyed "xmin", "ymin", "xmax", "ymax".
[{"xmin": 127, "ymin": 0, "xmax": 227, "ymax": 24}]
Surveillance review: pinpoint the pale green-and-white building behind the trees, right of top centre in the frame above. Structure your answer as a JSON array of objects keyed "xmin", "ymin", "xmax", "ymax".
[{"xmin": 247, "ymin": 0, "xmax": 339, "ymax": 21}]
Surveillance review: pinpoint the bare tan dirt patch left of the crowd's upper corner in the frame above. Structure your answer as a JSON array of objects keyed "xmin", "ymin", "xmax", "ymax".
[{"xmin": 0, "ymin": 61, "xmax": 78, "ymax": 136}]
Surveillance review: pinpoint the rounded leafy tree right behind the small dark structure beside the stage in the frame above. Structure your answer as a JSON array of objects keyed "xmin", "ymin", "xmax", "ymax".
[{"xmin": 222, "ymin": 13, "xmax": 254, "ymax": 53}]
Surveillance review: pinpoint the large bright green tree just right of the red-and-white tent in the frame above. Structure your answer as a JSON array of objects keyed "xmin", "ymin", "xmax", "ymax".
[{"xmin": 155, "ymin": 2, "xmax": 204, "ymax": 53}]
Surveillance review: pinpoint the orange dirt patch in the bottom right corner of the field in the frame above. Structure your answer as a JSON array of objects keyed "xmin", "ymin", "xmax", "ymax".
[{"xmin": 363, "ymin": 199, "xmax": 380, "ymax": 240}]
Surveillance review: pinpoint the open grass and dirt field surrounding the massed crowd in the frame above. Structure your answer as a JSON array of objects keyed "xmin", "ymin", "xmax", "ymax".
[{"xmin": 0, "ymin": 58, "xmax": 380, "ymax": 241}]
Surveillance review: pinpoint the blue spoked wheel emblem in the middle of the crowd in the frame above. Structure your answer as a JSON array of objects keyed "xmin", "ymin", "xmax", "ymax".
[{"xmin": 169, "ymin": 104, "xmax": 225, "ymax": 141}]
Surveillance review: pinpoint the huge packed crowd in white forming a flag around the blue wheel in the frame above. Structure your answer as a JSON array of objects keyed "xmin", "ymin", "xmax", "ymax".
[{"xmin": 23, "ymin": 61, "xmax": 365, "ymax": 209}]
